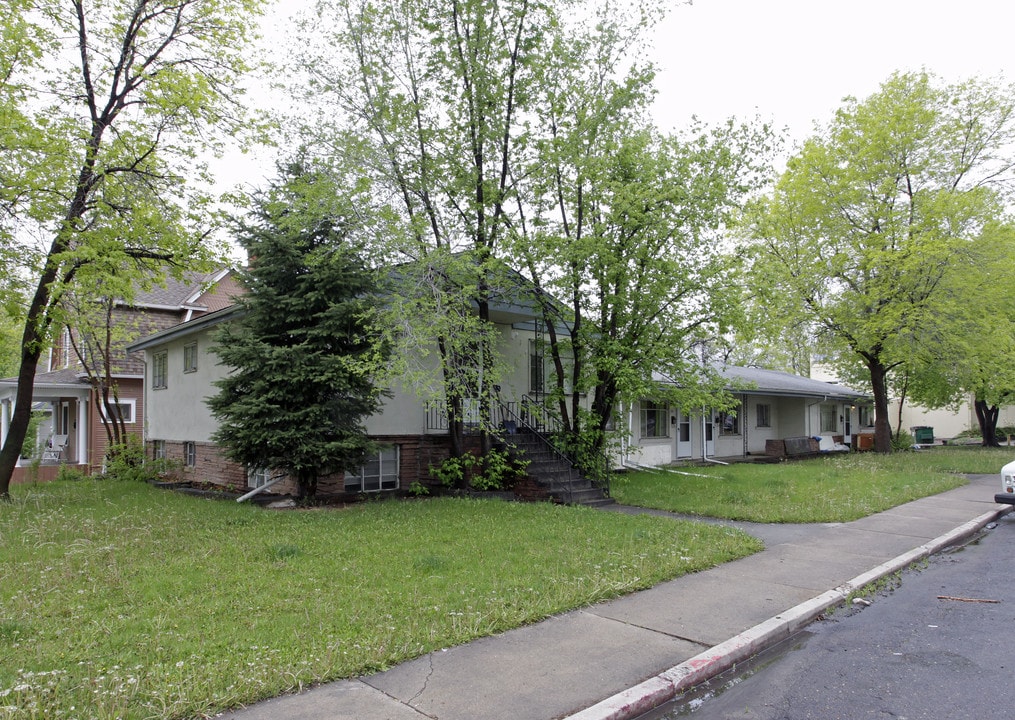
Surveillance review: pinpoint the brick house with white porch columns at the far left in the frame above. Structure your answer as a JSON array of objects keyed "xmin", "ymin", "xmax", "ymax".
[{"xmin": 0, "ymin": 269, "xmax": 239, "ymax": 482}]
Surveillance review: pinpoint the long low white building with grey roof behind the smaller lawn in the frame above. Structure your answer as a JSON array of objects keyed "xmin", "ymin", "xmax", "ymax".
[{"xmin": 623, "ymin": 366, "xmax": 874, "ymax": 466}]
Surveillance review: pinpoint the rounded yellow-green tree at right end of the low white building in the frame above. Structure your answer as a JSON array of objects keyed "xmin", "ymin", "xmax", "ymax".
[{"xmin": 753, "ymin": 73, "xmax": 1015, "ymax": 452}]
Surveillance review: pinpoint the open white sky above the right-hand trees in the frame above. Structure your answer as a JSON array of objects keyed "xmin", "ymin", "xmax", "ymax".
[{"xmin": 652, "ymin": 0, "xmax": 1015, "ymax": 142}]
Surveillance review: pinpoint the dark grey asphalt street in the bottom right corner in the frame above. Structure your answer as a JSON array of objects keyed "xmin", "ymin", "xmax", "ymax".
[{"xmin": 642, "ymin": 507, "xmax": 1015, "ymax": 720}]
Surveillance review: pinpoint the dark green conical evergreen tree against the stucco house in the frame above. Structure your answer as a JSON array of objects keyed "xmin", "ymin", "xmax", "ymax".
[{"xmin": 208, "ymin": 170, "xmax": 385, "ymax": 500}]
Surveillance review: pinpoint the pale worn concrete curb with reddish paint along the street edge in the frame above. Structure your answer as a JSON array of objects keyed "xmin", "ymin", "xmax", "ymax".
[{"xmin": 561, "ymin": 506, "xmax": 1015, "ymax": 720}]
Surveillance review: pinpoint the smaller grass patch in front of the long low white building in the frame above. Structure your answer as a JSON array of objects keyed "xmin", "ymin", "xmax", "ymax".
[{"xmin": 611, "ymin": 448, "xmax": 1015, "ymax": 523}]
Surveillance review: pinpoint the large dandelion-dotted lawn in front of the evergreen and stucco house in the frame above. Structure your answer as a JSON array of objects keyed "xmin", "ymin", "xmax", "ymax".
[{"xmin": 0, "ymin": 480, "xmax": 760, "ymax": 718}]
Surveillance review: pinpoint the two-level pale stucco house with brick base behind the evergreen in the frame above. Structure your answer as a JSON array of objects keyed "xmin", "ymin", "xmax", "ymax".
[{"xmin": 129, "ymin": 276, "xmax": 584, "ymax": 496}]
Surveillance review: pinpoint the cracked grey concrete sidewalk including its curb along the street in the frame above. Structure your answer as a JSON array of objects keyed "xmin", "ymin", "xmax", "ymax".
[{"xmin": 220, "ymin": 475, "xmax": 1012, "ymax": 720}]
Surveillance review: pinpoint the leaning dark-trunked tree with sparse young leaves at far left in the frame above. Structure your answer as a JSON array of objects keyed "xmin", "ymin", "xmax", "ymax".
[{"xmin": 0, "ymin": 0, "xmax": 264, "ymax": 497}]
